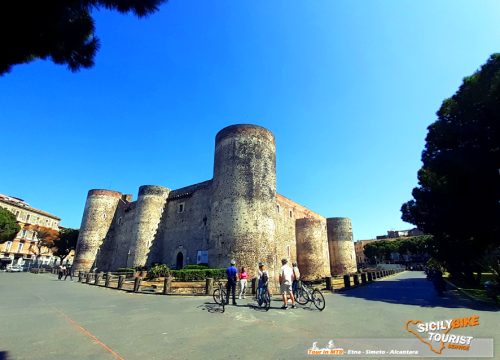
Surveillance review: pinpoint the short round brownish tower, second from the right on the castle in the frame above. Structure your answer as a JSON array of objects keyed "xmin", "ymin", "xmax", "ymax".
[{"xmin": 295, "ymin": 218, "xmax": 330, "ymax": 280}]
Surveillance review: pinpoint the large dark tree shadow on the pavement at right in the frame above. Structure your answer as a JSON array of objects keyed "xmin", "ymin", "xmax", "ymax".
[{"xmin": 340, "ymin": 273, "xmax": 498, "ymax": 311}]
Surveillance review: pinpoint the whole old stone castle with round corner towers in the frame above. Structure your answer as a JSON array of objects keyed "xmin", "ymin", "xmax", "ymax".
[{"xmin": 74, "ymin": 125, "xmax": 357, "ymax": 279}]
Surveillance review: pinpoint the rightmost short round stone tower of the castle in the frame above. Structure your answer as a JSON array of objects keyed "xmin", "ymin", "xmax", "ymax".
[{"xmin": 326, "ymin": 218, "xmax": 358, "ymax": 275}]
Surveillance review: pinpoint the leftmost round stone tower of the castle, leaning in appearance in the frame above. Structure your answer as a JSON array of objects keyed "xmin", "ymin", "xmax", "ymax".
[{"xmin": 73, "ymin": 189, "xmax": 122, "ymax": 271}]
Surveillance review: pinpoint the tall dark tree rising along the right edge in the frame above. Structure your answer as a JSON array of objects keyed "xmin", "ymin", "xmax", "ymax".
[{"xmin": 401, "ymin": 54, "xmax": 500, "ymax": 282}]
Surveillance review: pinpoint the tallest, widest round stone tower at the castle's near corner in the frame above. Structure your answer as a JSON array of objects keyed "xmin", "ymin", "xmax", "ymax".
[{"xmin": 208, "ymin": 125, "xmax": 281, "ymax": 280}]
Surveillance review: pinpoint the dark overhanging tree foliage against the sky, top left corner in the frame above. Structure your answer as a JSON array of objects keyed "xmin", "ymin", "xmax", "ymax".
[{"xmin": 0, "ymin": 0, "xmax": 165, "ymax": 75}]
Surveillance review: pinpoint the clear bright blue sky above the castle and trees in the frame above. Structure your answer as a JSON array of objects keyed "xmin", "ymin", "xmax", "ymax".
[{"xmin": 0, "ymin": 0, "xmax": 500, "ymax": 240}]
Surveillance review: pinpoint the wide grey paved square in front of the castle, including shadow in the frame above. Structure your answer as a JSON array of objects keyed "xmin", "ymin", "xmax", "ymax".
[{"xmin": 0, "ymin": 272, "xmax": 500, "ymax": 360}]
